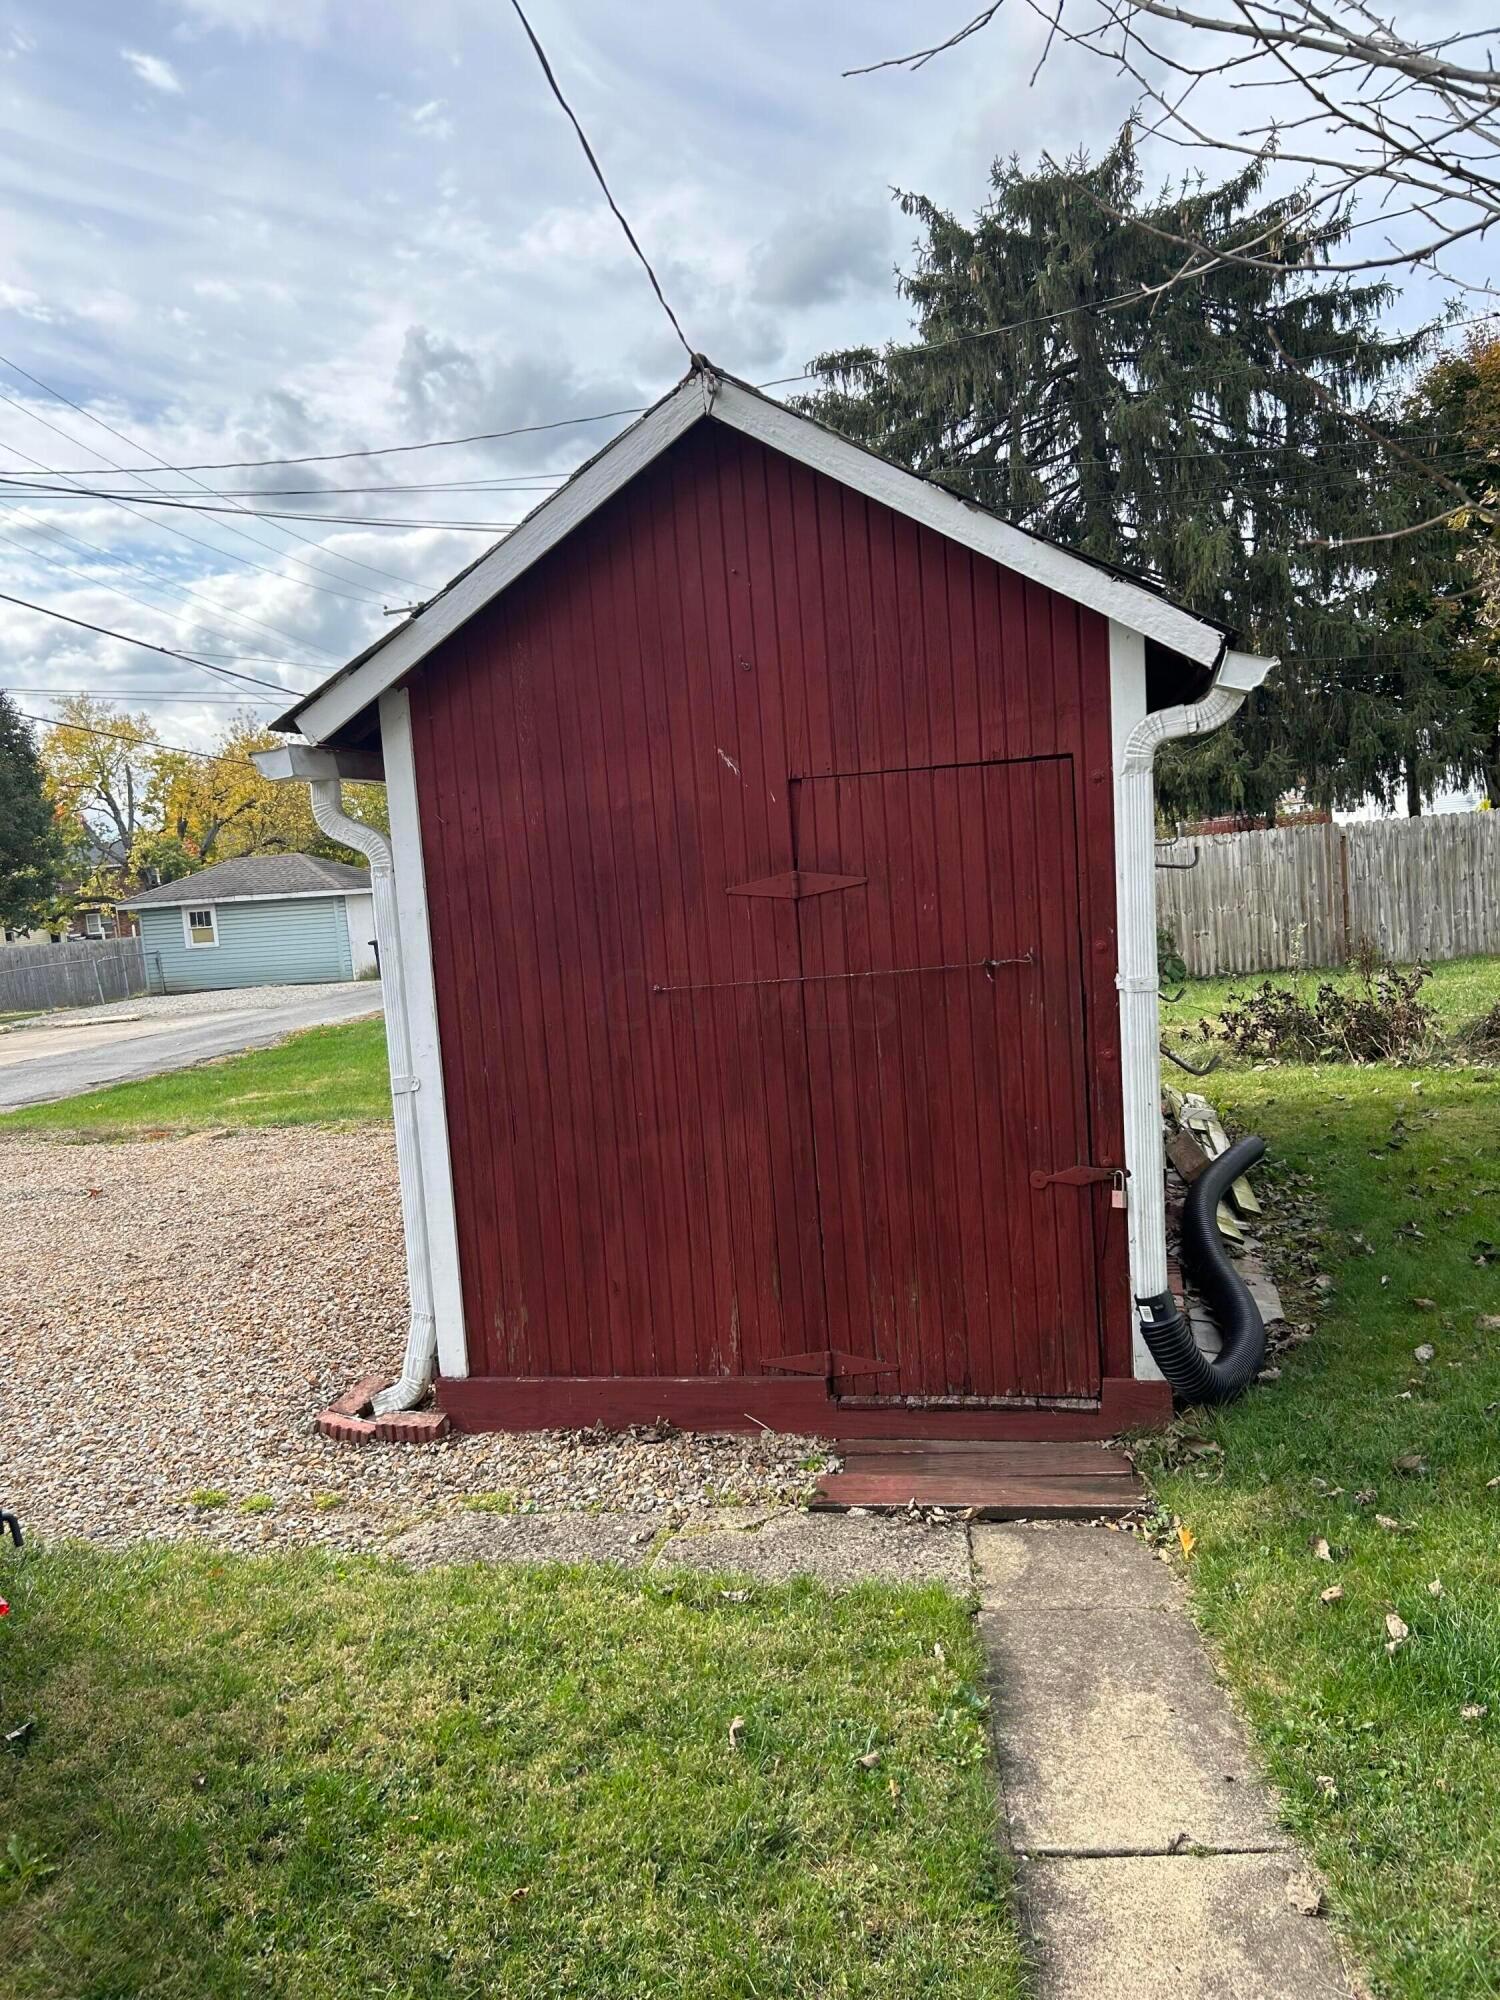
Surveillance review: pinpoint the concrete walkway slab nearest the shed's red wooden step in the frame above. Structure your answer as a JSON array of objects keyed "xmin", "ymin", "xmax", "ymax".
[{"xmin": 980, "ymin": 1600, "xmax": 1286, "ymax": 1854}]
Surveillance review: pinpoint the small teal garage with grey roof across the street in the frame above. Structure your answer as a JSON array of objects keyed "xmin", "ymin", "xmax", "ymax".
[{"xmin": 120, "ymin": 854, "xmax": 380, "ymax": 994}]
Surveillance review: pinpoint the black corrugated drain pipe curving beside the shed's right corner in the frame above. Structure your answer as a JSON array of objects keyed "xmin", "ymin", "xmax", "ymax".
[{"xmin": 1136, "ymin": 1138, "xmax": 1266, "ymax": 1402}]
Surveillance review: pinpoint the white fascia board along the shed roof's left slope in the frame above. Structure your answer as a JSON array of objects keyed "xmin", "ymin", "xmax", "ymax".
[{"xmin": 300, "ymin": 376, "xmax": 704, "ymax": 756}]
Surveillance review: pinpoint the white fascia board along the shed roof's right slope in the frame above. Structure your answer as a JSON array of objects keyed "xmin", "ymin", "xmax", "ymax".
[{"xmin": 714, "ymin": 382, "xmax": 1224, "ymax": 666}]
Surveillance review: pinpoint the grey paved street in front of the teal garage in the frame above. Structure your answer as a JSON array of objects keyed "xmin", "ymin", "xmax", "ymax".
[{"xmin": 0, "ymin": 980, "xmax": 380, "ymax": 1110}]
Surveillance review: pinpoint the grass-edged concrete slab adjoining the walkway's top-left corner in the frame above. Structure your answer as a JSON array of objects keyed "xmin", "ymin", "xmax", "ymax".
[{"xmin": 656, "ymin": 1510, "xmax": 974, "ymax": 1596}]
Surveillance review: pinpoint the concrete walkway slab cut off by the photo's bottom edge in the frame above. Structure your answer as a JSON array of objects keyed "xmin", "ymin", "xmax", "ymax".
[{"xmin": 1020, "ymin": 1854, "xmax": 1358, "ymax": 2000}]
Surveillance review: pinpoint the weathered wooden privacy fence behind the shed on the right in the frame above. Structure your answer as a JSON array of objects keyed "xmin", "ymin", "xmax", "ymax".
[{"xmin": 1156, "ymin": 812, "xmax": 1500, "ymax": 974}]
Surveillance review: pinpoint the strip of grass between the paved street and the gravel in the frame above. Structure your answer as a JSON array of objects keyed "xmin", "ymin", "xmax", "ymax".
[{"xmin": 0, "ymin": 1014, "xmax": 390, "ymax": 1138}]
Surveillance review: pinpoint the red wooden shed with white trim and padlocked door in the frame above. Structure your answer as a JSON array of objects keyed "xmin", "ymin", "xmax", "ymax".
[{"xmin": 264, "ymin": 366, "xmax": 1268, "ymax": 1438}]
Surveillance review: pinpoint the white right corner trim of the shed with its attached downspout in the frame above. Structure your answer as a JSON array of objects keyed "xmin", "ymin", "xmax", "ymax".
[{"xmin": 1110, "ymin": 620, "xmax": 1276, "ymax": 1380}]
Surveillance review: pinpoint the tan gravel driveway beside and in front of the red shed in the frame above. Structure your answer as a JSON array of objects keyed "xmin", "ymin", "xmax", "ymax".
[{"xmin": 0, "ymin": 1128, "xmax": 822, "ymax": 1548}]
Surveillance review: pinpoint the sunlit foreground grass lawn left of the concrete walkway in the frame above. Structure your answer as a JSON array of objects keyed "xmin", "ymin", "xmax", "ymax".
[{"xmin": 0, "ymin": 1546, "xmax": 1020, "ymax": 2000}]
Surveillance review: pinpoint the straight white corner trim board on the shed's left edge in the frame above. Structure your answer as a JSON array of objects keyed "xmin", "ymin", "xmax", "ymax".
[{"xmin": 380, "ymin": 688, "xmax": 468, "ymax": 1376}]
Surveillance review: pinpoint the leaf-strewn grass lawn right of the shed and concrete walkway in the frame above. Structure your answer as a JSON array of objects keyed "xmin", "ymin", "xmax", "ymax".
[{"xmin": 1148, "ymin": 1056, "xmax": 1500, "ymax": 2000}]
